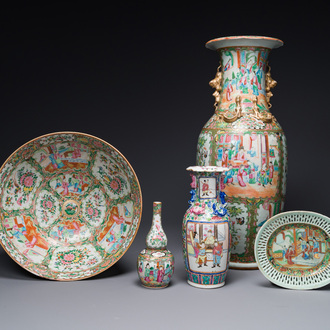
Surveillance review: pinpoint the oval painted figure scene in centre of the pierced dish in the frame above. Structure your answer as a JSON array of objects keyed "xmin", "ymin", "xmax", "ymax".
[{"xmin": 270, "ymin": 227, "xmax": 329, "ymax": 269}]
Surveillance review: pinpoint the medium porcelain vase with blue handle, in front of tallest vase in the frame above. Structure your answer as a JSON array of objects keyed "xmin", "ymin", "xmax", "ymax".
[{"xmin": 182, "ymin": 166, "xmax": 231, "ymax": 288}]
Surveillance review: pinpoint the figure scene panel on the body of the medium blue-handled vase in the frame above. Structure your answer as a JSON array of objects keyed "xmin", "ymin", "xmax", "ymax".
[{"xmin": 187, "ymin": 221, "xmax": 229, "ymax": 273}]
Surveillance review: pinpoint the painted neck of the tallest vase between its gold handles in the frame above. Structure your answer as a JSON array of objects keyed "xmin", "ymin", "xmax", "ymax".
[{"xmin": 216, "ymin": 47, "xmax": 270, "ymax": 114}]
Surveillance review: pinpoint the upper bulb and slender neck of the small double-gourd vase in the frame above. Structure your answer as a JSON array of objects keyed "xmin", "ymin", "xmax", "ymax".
[{"xmin": 146, "ymin": 202, "xmax": 167, "ymax": 249}]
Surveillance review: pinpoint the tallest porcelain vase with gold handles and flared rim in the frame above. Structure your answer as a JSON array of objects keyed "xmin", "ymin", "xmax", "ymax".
[{"xmin": 197, "ymin": 36, "xmax": 287, "ymax": 269}]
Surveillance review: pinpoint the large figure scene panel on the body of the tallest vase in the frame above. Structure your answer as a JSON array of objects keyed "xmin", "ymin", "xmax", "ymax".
[{"xmin": 216, "ymin": 133, "xmax": 280, "ymax": 197}]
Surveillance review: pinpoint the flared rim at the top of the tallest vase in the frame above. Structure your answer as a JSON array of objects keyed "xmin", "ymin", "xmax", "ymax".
[{"xmin": 205, "ymin": 36, "xmax": 284, "ymax": 50}]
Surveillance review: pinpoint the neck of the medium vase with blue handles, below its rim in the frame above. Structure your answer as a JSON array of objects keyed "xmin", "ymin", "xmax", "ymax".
[{"xmin": 191, "ymin": 172, "xmax": 222, "ymax": 202}]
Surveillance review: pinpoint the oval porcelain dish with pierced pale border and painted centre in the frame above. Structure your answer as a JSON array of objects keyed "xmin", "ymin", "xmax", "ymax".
[{"xmin": 254, "ymin": 211, "xmax": 330, "ymax": 290}]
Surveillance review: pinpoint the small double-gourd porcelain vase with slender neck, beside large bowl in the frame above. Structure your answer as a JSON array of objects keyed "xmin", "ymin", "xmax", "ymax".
[{"xmin": 137, "ymin": 202, "xmax": 174, "ymax": 289}]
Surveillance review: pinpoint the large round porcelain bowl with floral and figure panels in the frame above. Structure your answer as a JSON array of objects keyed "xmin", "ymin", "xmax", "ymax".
[{"xmin": 0, "ymin": 132, "xmax": 142, "ymax": 280}]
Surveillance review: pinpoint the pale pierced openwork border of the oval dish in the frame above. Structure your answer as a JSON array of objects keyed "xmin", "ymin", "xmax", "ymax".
[{"xmin": 254, "ymin": 211, "xmax": 330, "ymax": 290}]
